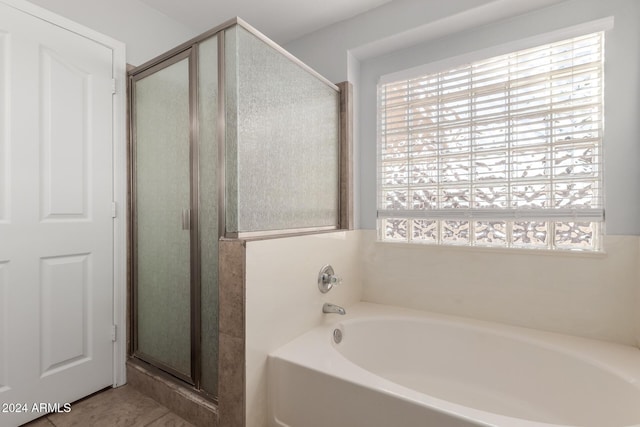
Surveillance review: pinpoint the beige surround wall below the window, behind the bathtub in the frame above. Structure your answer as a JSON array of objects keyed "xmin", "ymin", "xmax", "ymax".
[{"xmin": 363, "ymin": 231, "xmax": 640, "ymax": 345}]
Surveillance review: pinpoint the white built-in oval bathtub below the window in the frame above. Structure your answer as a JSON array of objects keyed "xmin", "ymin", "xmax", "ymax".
[{"xmin": 268, "ymin": 303, "xmax": 640, "ymax": 427}]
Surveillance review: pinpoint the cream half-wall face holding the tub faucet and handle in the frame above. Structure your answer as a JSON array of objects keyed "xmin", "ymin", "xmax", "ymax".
[{"xmin": 245, "ymin": 231, "xmax": 362, "ymax": 427}]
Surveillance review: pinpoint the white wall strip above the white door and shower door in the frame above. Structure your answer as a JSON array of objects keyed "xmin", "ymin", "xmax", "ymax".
[{"xmin": 30, "ymin": 0, "xmax": 200, "ymax": 65}]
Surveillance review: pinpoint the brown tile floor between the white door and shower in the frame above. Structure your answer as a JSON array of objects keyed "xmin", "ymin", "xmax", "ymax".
[{"xmin": 24, "ymin": 385, "xmax": 195, "ymax": 427}]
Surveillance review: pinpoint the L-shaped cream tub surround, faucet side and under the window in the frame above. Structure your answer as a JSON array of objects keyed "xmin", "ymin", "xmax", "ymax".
[{"xmin": 252, "ymin": 230, "xmax": 640, "ymax": 427}]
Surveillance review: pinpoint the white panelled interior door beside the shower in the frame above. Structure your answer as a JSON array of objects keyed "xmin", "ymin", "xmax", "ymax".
[{"xmin": 0, "ymin": 2, "xmax": 113, "ymax": 427}]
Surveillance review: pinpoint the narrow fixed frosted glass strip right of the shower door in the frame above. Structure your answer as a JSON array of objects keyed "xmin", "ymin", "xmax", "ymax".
[{"xmin": 198, "ymin": 37, "xmax": 218, "ymax": 396}]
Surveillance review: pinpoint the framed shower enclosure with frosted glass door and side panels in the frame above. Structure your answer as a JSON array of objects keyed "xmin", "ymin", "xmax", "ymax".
[{"xmin": 129, "ymin": 18, "xmax": 345, "ymax": 401}]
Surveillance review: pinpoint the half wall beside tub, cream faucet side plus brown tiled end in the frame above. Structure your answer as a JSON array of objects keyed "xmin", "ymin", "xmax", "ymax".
[{"xmin": 218, "ymin": 230, "xmax": 362, "ymax": 427}]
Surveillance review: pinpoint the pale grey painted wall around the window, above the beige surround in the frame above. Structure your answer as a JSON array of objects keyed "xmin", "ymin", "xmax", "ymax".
[{"xmin": 285, "ymin": 0, "xmax": 640, "ymax": 235}]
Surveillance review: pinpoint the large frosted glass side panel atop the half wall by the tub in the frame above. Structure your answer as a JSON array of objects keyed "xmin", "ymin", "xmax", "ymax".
[{"xmin": 225, "ymin": 26, "xmax": 339, "ymax": 232}]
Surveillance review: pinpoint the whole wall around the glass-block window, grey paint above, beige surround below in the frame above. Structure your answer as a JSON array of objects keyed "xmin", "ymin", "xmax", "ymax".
[{"xmin": 285, "ymin": 0, "xmax": 640, "ymax": 344}]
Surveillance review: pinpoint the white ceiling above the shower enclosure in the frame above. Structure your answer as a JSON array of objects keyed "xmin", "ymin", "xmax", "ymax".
[{"xmin": 139, "ymin": 0, "xmax": 391, "ymax": 44}]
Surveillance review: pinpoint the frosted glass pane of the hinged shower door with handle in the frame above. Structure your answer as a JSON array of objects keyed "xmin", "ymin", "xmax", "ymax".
[{"xmin": 134, "ymin": 59, "xmax": 191, "ymax": 377}]
